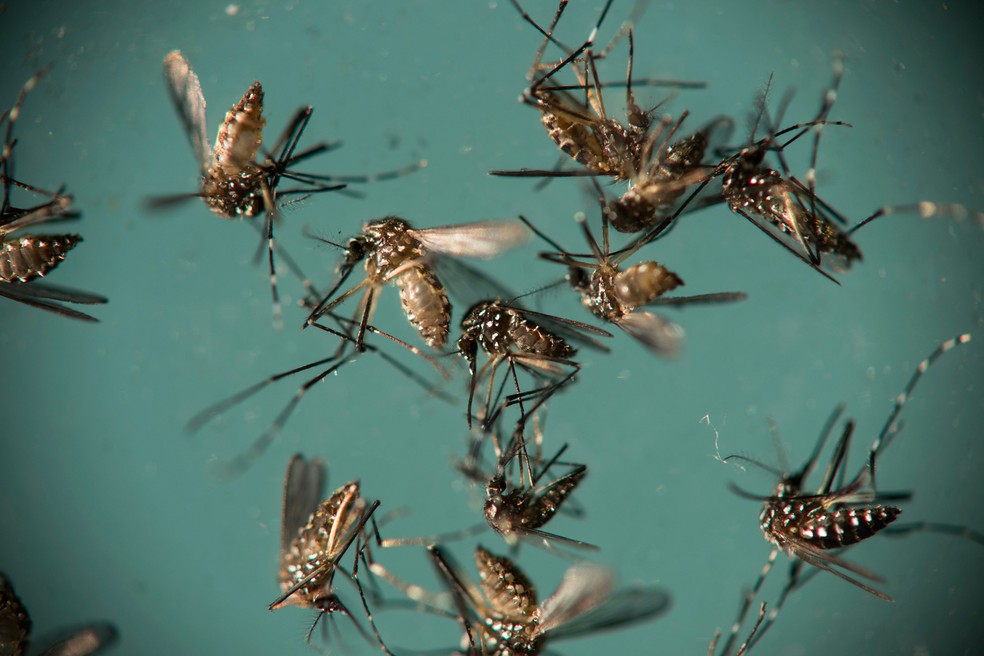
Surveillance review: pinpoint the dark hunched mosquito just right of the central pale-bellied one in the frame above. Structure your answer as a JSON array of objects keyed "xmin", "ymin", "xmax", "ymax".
[{"xmin": 458, "ymin": 299, "xmax": 612, "ymax": 428}]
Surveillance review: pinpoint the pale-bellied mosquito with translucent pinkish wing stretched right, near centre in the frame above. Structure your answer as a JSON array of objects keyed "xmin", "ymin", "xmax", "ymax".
[{"xmin": 305, "ymin": 216, "xmax": 529, "ymax": 350}]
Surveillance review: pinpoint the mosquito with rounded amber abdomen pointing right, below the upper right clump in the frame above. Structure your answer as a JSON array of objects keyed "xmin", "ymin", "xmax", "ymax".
[{"xmin": 520, "ymin": 205, "xmax": 746, "ymax": 356}]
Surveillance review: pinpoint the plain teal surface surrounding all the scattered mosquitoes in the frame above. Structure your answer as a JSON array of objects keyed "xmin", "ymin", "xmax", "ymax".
[{"xmin": 0, "ymin": 0, "xmax": 984, "ymax": 655}]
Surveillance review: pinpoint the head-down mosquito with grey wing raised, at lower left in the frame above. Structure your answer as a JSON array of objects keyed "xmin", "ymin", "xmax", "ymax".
[{"xmin": 270, "ymin": 454, "xmax": 388, "ymax": 643}]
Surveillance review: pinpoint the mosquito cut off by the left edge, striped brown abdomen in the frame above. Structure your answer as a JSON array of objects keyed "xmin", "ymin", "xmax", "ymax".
[{"xmin": 0, "ymin": 68, "xmax": 107, "ymax": 322}]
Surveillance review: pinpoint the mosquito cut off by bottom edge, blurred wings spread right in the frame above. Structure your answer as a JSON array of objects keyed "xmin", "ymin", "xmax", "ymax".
[{"xmin": 373, "ymin": 545, "xmax": 670, "ymax": 656}]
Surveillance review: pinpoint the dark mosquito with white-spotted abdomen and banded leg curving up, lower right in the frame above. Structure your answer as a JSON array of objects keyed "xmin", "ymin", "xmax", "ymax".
[{"xmin": 724, "ymin": 333, "xmax": 971, "ymax": 653}]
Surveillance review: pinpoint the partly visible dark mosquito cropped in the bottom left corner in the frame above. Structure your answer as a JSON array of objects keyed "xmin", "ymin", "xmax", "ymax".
[{"xmin": 0, "ymin": 572, "xmax": 117, "ymax": 656}]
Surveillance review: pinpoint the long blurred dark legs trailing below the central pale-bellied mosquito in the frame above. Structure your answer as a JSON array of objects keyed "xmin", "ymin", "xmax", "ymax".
[{"xmin": 185, "ymin": 314, "xmax": 449, "ymax": 478}]
